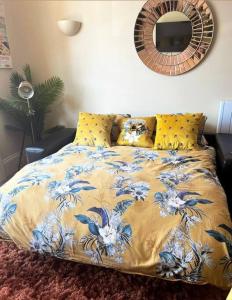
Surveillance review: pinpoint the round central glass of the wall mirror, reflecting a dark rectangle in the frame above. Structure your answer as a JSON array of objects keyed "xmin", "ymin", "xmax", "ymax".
[{"xmin": 153, "ymin": 11, "xmax": 192, "ymax": 55}]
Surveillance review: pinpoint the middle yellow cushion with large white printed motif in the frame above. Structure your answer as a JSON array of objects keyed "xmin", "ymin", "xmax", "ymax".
[{"xmin": 117, "ymin": 117, "xmax": 155, "ymax": 148}]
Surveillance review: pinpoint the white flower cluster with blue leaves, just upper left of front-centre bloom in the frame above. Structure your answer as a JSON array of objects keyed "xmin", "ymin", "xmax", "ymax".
[{"xmin": 47, "ymin": 180, "xmax": 96, "ymax": 211}]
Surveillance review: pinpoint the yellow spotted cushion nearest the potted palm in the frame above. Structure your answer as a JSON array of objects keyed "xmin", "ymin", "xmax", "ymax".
[{"xmin": 74, "ymin": 112, "xmax": 115, "ymax": 147}]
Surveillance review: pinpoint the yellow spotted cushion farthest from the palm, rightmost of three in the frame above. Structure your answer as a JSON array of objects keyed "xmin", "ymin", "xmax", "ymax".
[{"xmin": 154, "ymin": 113, "xmax": 203, "ymax": 150}]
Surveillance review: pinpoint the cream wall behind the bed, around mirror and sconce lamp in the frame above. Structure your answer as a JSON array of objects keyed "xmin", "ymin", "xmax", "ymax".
[{"xmin": 0, "ymin": 0, "xmax": 232, "ymax": 178}]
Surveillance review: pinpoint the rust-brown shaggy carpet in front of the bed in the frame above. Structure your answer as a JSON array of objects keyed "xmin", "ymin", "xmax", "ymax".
[{"xmin": 0, "ymin": 242, "xmax": 228, "ymax": 300}]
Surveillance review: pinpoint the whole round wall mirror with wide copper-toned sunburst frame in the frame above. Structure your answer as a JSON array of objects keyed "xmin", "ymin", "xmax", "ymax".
[{"xmin": 134, "ymin": 0, "xmax": 214, "ymax": 76}]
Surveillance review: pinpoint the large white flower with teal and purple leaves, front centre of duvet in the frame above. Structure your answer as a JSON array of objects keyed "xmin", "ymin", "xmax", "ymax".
[{"xmin": 75, "ymin": 200, "xmax": 132, "ymax": 263}]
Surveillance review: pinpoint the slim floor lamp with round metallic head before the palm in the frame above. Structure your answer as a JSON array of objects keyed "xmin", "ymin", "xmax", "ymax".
[{"xmin": 18, "ymin": 81, "xmax": 35, "ymax": 170}]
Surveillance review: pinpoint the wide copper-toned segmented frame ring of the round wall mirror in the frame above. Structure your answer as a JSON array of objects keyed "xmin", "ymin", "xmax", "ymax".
[{"xmin": 134, "ymin": 0, "xmax": 214, "ymax": 76}]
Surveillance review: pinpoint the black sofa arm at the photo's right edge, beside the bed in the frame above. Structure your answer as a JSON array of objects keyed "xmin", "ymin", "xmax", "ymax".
[{"xmin": 216, "ymin": 133, "xmax": 232, "ymax": 213}]
